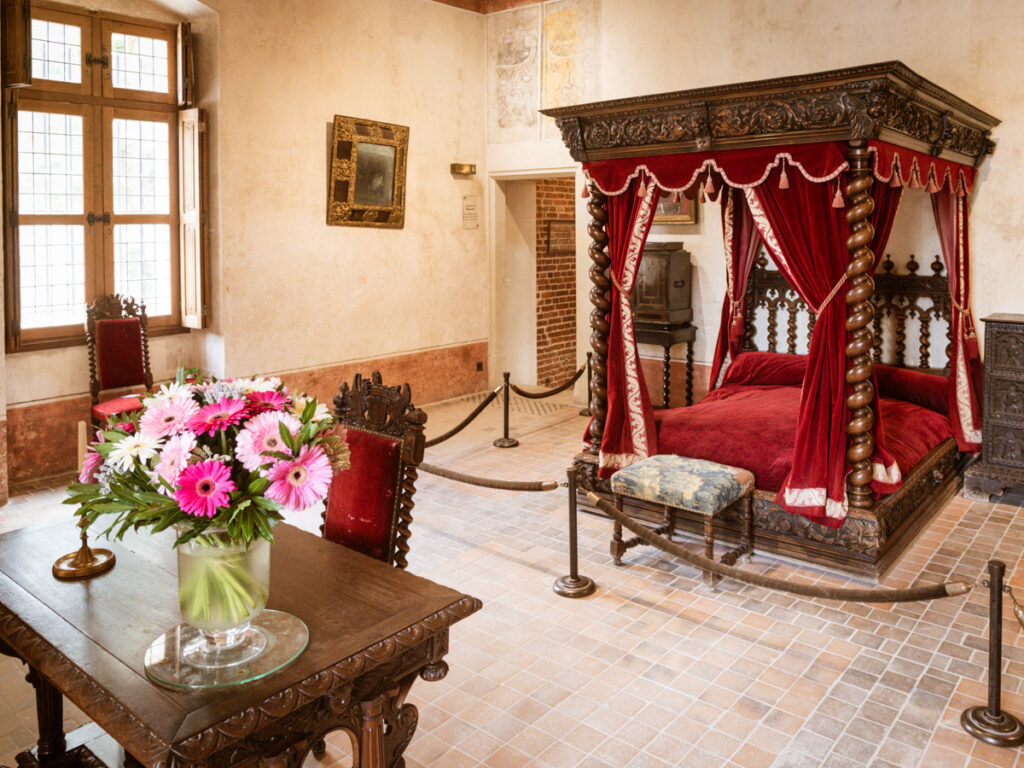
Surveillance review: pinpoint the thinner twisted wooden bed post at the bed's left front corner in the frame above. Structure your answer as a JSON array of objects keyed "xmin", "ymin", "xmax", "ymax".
[{"xmin": 587, "ymin": 184, "xmax": 611, "ymax": 454}]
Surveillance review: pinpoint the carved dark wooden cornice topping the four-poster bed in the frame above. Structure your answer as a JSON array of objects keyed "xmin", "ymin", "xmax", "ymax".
[{"xmin": 542, "ymin": 61, "xmax": 999, "ymax": 167}]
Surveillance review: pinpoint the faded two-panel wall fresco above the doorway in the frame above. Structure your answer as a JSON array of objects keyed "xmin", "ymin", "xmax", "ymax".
[{"xmin": 487, "ymin": 0, "xmax": 601, "ymax": 143}]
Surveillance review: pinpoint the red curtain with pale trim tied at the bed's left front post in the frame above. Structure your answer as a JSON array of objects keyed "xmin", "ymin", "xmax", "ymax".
[{"xmin": 598, "ymin": 172, "xmax": 660, "ymax": 477}]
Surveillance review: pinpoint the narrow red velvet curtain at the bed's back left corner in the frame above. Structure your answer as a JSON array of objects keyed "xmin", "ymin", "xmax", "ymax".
[{"xmin": 709, "ymin": 187, "xmax": 761, "ymax": 389}]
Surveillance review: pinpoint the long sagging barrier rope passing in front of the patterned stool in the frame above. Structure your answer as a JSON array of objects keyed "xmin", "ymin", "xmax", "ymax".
[{"xmin": 589, "ymin": 488, "xmax": 975, "ymax": 603}]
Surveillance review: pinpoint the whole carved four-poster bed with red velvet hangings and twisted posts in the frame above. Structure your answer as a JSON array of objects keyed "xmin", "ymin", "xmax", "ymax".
[{"xmin": 545, "ymin": 62, "xmax": 998, "ymax": 577}]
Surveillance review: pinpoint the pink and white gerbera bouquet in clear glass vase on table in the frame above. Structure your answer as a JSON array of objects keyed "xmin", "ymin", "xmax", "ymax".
[{"xmin": 66, "ymin": 371, "xmax": 348, "ymax": 663}]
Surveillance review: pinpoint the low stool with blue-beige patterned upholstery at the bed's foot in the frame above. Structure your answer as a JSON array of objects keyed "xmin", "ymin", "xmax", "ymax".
[{"xmin": 611, "ymin": 454, "xmax": 754, "ymax": 591}]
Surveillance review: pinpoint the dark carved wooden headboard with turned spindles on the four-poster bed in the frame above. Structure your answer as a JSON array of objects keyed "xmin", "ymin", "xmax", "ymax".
[{"xmin": 743, "ymin": 251, "xmax": 952, "ymax": 375}]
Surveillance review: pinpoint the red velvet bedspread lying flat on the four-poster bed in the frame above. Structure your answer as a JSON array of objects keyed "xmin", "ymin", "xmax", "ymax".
[{"xmin": 654, "ymin": 384, "xmax": 952, "ymax": 490}]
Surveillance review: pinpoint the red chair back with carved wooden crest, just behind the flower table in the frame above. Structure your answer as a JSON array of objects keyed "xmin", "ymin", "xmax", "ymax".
[{"xmin": 321, "ymin": 371, "xmax": 427, "ymax": 568}]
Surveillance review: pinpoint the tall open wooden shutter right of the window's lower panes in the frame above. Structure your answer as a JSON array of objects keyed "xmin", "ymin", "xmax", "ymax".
[{"xmin": 178, "ymin": 109, "xmax": 210, "ymax": 329}]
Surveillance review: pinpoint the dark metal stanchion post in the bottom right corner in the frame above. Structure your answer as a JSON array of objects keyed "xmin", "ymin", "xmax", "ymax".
[{"xmin": 961, "ymin": 560, "xmax": 1024, "ymax": 746}]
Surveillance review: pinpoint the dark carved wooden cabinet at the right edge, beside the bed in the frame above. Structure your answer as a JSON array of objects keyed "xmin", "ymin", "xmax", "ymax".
[{"xmin": 965, "ymin": 314, "xmax": 1024, "ymax": 499}]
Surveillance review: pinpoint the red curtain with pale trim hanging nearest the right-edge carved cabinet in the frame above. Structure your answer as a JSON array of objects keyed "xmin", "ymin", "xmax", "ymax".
[{"xmin": 932, "ymin": 189, "xmax": 982, "ymax": 452}]
